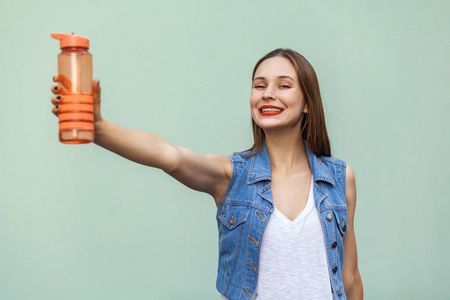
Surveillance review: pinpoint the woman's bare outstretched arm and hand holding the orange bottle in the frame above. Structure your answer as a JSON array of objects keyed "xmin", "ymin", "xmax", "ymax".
[{"xmin": 52, "ymin": 76, "xmax": 232, "ymax": 204}]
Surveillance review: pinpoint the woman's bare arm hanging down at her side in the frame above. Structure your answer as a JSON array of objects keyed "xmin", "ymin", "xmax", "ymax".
[{"xmin": 342, "ymin": 164, "xmax": 363, "ymax": 300}]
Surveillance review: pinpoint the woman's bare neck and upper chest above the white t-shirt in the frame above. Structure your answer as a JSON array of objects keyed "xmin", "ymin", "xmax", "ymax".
[{"xmin": 265, "ymin": 132, "xmax": 310, "ymax": 175}]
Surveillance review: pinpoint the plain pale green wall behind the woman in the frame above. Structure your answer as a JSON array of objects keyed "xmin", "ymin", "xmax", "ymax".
[{"xmin": 0, "ymin": 0, "xmax": 450, "ymax": 300}]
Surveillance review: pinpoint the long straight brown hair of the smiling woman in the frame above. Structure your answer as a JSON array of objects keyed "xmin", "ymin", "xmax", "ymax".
[{"xmin": 246, "ymin": 48, "xmax": 331, "ymax": 156}]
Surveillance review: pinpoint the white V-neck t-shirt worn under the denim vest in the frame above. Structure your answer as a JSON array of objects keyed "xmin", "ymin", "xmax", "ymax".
[{"xmin": 220, "ymin": 178, "xmax": 332, "ymax": 300}]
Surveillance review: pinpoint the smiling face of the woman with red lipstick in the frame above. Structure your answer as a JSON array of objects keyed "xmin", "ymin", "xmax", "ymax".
[{"xmin": 250, "ymin": 56, "xmax": 307, "ymax": 132}]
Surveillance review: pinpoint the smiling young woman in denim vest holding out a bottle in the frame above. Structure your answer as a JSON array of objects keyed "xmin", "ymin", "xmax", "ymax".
[{"xmin": 52, "ymin": 49, "xmax": 363, "ymax": 300}]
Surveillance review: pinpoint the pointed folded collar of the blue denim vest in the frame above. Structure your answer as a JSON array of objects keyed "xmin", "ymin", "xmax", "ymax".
[{"xmin": 247, "ymin": 140, "xmax": 336, "ymax": 185}]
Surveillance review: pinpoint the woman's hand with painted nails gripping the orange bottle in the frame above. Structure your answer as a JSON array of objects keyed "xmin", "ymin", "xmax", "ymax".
[{"xmin": 51, "ymin": 75, "xmax": 103, "ymax": 126}]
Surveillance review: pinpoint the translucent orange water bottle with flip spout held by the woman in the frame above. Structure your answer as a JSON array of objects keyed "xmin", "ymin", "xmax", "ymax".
[{"xmin": 51, "ymin": 33, "xmax": 94, "ymax": 144}]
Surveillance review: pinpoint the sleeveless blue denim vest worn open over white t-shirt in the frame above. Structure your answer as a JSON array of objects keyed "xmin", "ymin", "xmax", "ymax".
[{"xmin": 216, "ymin": 140, "xmax": 348, "ymax": 300}]
